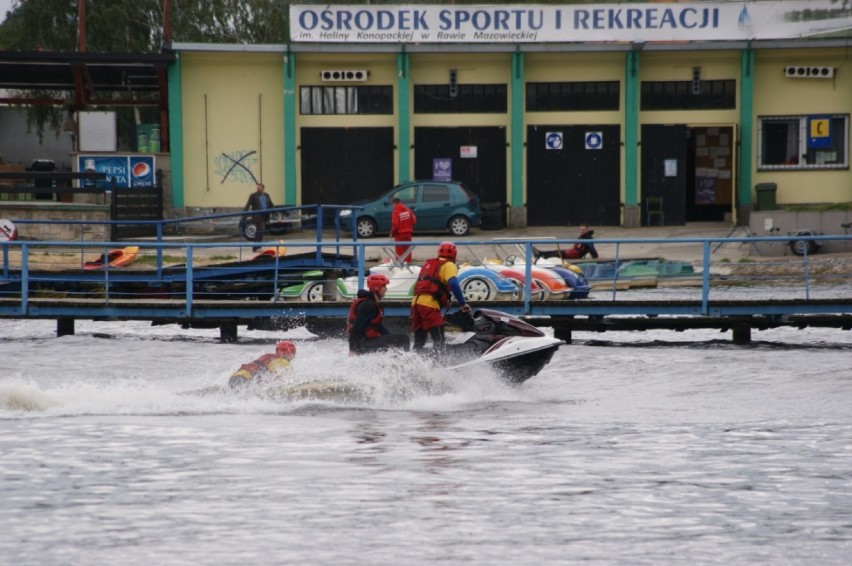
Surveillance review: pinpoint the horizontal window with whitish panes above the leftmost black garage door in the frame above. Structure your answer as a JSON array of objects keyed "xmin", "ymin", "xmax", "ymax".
[{"xmin": 299, "ymin": 86, "xmax": 393, "ymax": 114}]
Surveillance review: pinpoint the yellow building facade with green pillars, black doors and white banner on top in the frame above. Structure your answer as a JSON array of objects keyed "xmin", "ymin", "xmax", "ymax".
[{"xmin": 169, "ymin": 2, "xmax": 852, "ymax": 226}]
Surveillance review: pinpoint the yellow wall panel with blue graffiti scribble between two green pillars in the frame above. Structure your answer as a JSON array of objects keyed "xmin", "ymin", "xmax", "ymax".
[{"xmin": 181, "ymin": 52, "xmax": 284, "ymax": 208}]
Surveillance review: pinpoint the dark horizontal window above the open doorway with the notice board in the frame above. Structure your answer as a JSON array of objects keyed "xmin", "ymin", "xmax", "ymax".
[{"xmin": 640, "ymin": 79, "xmax": 737, "ymax": 110}]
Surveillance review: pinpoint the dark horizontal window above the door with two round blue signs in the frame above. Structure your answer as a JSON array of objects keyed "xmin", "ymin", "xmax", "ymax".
[{"xmin": 527, "ymin": 81, "xmax": 619, "ymax": 112}]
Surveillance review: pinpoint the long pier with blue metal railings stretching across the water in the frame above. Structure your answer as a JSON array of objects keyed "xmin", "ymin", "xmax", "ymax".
[{"xmin": 0, "ymin": 214, "xmax": 852, "ymax": 344}]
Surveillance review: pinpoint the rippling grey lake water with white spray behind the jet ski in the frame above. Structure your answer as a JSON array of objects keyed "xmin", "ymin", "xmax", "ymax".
[{"xmin": 0, "ymin": 320, "xmax": 852, "ymax": 565}]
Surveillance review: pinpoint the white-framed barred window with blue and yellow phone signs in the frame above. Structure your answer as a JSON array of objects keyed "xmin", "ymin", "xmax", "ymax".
[{"xmin": 757, "ymin": 114, "xmax": 849, "ymax": 170}]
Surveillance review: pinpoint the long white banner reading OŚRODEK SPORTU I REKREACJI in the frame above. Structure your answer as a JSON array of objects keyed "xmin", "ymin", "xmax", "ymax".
[{"xmin": 290, "ymin": 0, "xmax": 852, "ymax": 43}]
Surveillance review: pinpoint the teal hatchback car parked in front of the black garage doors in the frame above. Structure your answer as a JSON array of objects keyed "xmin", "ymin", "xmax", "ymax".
[{"xmin": 339, "ymin": 181, "xmax": 482, "ymax": 238}]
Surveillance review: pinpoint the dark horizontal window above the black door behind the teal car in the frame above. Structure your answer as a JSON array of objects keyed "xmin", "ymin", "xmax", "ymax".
[{"xmin": 414, "ymin": 84, "xmax": 508, "ymax": 114}]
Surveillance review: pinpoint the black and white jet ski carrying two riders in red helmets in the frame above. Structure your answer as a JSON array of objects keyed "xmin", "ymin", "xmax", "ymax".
[{"xmin": 446, "ymin": 309, "xmax": 565, "ymax": 384}]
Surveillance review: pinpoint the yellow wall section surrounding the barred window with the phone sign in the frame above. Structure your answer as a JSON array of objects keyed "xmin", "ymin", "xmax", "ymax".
[{"xmin": 752, "ymin": 49, "xmax": 852, "ymax": 204}]
